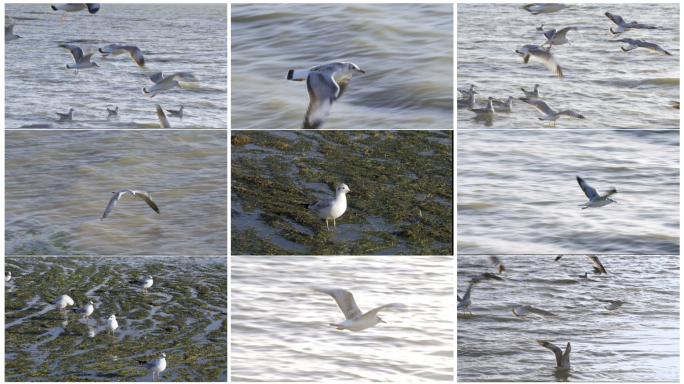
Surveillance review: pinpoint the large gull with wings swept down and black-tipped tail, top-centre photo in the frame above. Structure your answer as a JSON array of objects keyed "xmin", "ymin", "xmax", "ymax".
[{"xmin": 287, "ymin": 62, "xmax": 366, "ymax": 129}]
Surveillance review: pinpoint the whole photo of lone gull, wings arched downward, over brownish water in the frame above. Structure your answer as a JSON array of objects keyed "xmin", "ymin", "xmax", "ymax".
[{"xmin": 5, "ymin": 130, "xmax": 228, "ymax": 255}]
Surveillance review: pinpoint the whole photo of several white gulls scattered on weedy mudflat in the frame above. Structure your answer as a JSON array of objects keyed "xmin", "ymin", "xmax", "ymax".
[{"xmin": 5, "ymin": 256, "xmax": 228, "ymax": 382}]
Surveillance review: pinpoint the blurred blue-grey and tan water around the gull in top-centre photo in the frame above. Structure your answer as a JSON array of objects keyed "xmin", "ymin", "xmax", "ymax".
[{"xmin": 231, "ymin": 3, "xmax": 454, "ymax": 129}]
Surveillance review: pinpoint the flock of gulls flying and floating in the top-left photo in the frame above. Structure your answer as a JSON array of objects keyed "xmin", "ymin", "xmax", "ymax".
[{"xmin": 5, "ymin": 3, "xmax": 192, "ymax": 128}]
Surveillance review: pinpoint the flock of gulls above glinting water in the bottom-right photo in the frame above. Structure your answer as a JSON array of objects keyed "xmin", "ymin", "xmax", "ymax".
[{"xmin": 456, "ymin": 255, "xmax": 627, "ymax": 370}]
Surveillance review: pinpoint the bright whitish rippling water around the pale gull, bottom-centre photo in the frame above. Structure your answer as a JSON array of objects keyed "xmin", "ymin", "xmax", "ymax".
[{"xmin": 230, "ymin": 256, "xmax": 454, "ymax": 382}]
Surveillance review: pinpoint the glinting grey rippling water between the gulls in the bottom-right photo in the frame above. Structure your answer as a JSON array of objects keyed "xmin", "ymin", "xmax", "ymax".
[{"xmin": 457, "ymin": 255, "xmax": 680, "ymax": 382}]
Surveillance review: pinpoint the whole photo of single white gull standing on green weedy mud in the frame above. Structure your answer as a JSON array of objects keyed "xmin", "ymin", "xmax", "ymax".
[{"xmin": 230, "ymin": 130, "xmax": 454, "ymax": 255}]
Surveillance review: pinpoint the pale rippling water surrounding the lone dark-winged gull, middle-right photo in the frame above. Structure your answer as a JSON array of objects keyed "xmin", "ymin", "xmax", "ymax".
[{"xmin": 457, "ymin": 130, "xmax": 680, "ymax": 254}]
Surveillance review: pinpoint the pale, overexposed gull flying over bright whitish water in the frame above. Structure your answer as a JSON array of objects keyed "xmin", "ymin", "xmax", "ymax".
[{"xmin": 313, "ymin": 288, "xmax": 408, "ymax": 332}]
